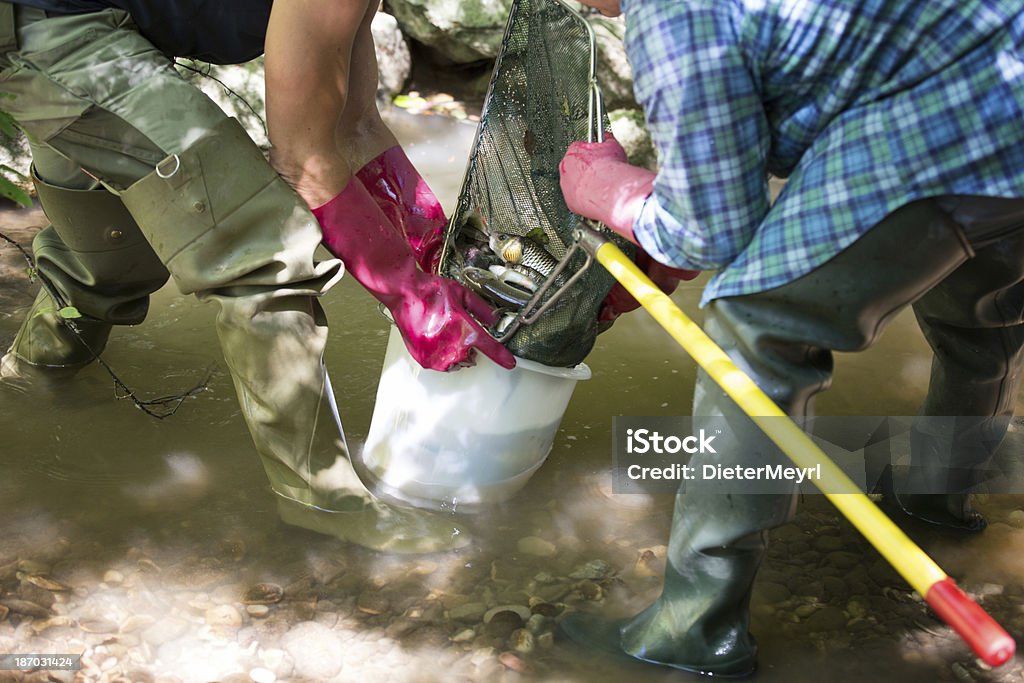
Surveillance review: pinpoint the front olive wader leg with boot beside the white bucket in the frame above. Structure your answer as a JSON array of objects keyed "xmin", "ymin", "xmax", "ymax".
[{"xmin": 122, "ymin": 119, "xmax": 463, "ymax": 552}]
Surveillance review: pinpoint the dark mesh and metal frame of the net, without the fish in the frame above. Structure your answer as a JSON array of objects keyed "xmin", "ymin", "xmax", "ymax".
[{"xmin": 439, "ymin": 0, "xmax": 632, "ymax": 366}]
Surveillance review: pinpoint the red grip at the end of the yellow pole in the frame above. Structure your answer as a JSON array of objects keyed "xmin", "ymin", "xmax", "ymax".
[{"xmin": 925, "ymin": 577, "xmax": 1017, "ymax": 667}]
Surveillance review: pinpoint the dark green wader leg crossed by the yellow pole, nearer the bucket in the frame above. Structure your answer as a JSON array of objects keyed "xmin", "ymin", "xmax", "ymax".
[{"xmin": 563, "ymin": 201, "xmax": 1019, "ymax": 676}]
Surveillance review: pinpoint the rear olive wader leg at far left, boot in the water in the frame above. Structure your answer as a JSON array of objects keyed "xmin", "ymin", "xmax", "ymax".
[{"xmin": 0, "ymin": 163, "xmax": 168, "ymax": 377}]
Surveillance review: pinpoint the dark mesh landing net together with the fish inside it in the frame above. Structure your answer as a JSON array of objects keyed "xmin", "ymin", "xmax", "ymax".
[{"xmin": 440, "ymin": 0, "xmax": 633, "ymax": 367}]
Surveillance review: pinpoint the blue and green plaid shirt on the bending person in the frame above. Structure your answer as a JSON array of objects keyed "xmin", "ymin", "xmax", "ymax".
[{"xmin": 622, "ymin": 0, "xmax": 1024, "ymax": 303}]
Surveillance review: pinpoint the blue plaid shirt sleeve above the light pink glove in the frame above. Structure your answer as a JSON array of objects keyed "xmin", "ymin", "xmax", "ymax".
[{"xmin": 626, "ymin": 0, "xmax": 770, "ymax": 270}]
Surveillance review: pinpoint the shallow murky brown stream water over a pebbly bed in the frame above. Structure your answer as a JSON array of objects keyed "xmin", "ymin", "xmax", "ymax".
[{"xmin": 0, "ymin": 108, "xmax": 1024, "ymax": 681}]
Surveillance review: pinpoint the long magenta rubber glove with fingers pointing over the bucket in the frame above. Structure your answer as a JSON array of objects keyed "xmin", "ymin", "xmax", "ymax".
[{"xmin": 313, "ymin": 178, "xmax": 515, "ymax": 371}]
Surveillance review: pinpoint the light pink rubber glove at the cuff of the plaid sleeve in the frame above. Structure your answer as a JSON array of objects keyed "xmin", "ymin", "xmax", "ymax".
[{"xmin": 558, "ymin": 135, "xmax": 654, "ymax": 244}]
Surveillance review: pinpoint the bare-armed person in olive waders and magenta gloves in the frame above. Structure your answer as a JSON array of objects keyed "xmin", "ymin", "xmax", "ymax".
[{"xmin": 0, "ymin": 0, "xmax": 515, "ymax": 552}]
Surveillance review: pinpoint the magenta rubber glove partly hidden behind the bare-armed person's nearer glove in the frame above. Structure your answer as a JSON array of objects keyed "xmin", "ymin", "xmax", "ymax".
[{"xmin": 355, "ymin": 145, "xmax": 447, "ymax": 272}]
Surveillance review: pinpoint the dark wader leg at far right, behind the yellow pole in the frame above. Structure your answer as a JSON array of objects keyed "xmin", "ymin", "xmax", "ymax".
[{"xmin": 897, "ymin": 229, "xmax": 1024, "ymax": 531}]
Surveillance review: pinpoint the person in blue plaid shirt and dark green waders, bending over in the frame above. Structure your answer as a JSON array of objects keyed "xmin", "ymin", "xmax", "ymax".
[{"xmin": 561, "ymin": 0, "xmax": 1024, "ymax": 676}]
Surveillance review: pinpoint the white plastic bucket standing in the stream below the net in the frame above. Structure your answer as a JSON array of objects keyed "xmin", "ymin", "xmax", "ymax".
[{"xmin": 361, "ymin": 327, "xmax": 590, "ymax": 507}]
